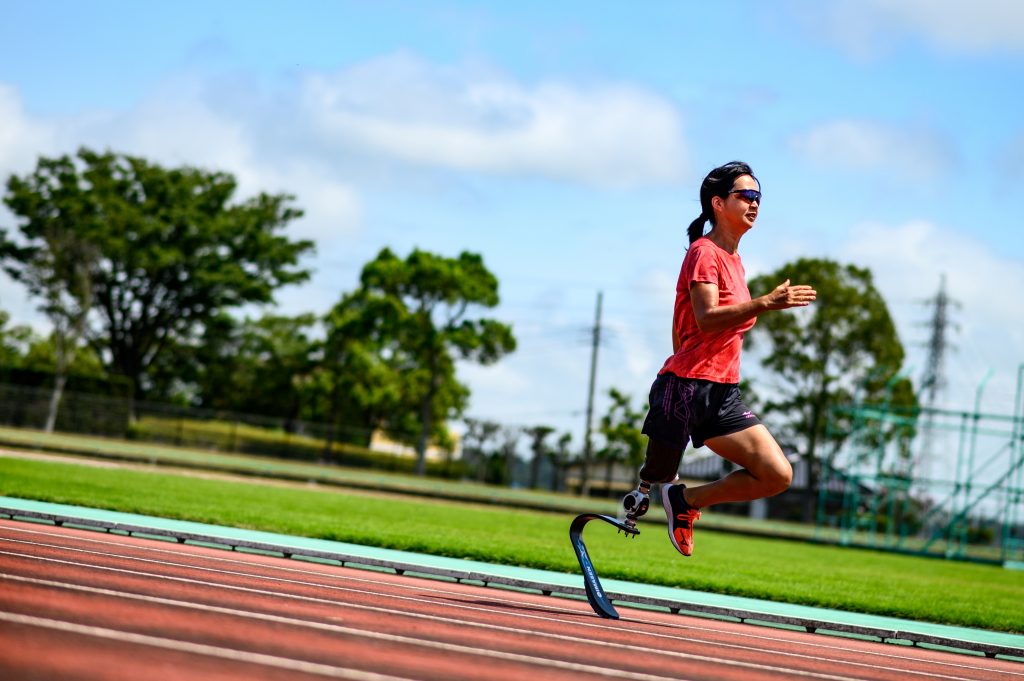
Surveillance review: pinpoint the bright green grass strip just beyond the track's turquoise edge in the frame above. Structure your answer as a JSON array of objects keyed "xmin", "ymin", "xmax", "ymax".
[{"xmin": 0, "ymin": 457, "xmax": 1024, "ymax": 633}]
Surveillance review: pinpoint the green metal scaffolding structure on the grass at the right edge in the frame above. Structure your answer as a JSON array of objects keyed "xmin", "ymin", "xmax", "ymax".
[{"xmin": 816, "ymin": 365, "xmax": 1024, "ymax": 567}]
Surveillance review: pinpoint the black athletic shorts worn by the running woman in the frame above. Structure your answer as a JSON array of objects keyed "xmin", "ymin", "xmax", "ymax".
[{"xmin": 643, "ymin": 373, "xmax": 761, "ymax": 453}]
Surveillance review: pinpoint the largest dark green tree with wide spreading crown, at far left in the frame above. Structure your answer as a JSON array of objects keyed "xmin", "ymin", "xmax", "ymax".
[{"xmin": 0, "ymin": 148, "xmax": 312, "ymax": 403}]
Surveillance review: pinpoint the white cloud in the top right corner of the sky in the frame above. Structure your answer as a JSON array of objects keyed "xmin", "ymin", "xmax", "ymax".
[{"xmin": 800, "ymin": 0, "xmax": 1024, "ymax": 56}]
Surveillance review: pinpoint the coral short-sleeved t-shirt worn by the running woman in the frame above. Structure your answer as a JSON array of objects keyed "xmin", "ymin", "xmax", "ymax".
[{"xmin": 658, "ymin": 238, "xmax": 757, "ymax": 383}]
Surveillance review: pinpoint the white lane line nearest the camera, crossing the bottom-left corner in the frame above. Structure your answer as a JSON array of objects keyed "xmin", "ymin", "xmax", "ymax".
[{"xmin": 0, "ymin": 610, "xmax": 412, "ymax": 681}]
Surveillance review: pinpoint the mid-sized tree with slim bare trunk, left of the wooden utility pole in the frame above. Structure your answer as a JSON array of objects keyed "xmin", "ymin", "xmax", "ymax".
[{"xmin": 360, "ymin": 249, "xmax": 515, "ymax": 475}]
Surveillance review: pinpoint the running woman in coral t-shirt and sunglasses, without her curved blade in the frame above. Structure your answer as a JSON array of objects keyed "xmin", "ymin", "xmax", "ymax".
[{"xmin": 623, "ymin": 161, "xmax": 816, "ymax": 556}]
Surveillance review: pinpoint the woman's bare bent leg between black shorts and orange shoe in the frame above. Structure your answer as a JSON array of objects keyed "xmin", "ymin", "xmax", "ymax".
[{"xmin": 683, "ymin": 425, "xmax": 793, "ymax": 508}]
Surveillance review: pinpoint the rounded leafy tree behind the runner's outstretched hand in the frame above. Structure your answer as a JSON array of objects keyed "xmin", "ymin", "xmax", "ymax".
[{"xmin": 750, "ymin": 258, "xmax": 913, "ymax": 520}]
